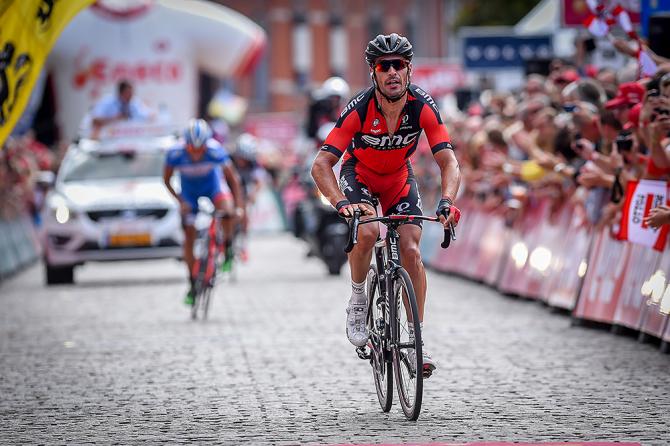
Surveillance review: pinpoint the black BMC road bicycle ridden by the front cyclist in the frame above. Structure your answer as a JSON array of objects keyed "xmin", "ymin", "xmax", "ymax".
[{"xmin": 345, "ymin": 210, "xmax": 456, "ymax": 421}]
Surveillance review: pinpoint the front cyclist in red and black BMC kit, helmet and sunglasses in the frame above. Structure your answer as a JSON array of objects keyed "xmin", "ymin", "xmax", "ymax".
[{"xmin": 312, "ymin": 33, "xmax": 460, "ymax": 372}]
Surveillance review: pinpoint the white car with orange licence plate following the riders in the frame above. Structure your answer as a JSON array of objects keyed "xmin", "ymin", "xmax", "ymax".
[{"xmin": 43, "ymin": 127, "xmax": 183, "ymax": 285}]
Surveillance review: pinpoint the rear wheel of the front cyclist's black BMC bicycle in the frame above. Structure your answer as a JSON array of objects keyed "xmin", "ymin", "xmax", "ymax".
[{"xmin": 367, "ymin": 265, "xmax": 393, "ymax": 412}]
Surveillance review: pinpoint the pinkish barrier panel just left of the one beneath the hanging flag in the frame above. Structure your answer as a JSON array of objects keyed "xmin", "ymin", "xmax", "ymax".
[{"xmin": 574, "ymin": 228, "xmax": 632, "ymax": 323}]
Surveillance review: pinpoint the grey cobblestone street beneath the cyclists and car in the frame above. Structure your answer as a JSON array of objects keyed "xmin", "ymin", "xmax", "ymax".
[{"xmin": 0, "ymin": 235, "xmax": 670, "ymax": 446}]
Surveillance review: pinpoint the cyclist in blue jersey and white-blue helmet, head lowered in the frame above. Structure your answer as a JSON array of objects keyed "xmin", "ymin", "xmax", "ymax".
[{"xmin": 163, "ymin": 119, "xmax": 244, "ymax": 304}]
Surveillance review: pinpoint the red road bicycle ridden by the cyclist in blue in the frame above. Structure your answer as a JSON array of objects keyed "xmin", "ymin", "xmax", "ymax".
[{"xmin": 191, "ymin": 210, "xmax": 233, "ymax": 320}]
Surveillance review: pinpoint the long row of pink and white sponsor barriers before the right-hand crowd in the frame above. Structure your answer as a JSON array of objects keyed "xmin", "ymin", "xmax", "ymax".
[{"xmin": 422, "ymin": 195, "xmax": 670, "ymax": 352}]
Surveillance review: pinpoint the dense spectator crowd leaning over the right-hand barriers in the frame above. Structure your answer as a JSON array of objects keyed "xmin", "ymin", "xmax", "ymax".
[{"xmin": 415, "ymin": 38, "xmax": 670, "ymax": 240}]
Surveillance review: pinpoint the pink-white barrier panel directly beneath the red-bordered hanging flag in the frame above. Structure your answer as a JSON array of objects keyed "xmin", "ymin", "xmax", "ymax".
[{"xmin": 614, "ymin": 245, "xmax": 665, "ymax": 330}]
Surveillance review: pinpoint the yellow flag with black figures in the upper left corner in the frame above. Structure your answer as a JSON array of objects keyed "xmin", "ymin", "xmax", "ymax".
[{"xmin": 0, "ymin": 0, "xmax": 94, "ymax": 145}]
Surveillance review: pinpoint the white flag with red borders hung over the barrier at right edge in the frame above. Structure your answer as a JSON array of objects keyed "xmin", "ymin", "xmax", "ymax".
[{"xmin": 617, "ymin": 180, "xmax": 668, "ymax": 251}]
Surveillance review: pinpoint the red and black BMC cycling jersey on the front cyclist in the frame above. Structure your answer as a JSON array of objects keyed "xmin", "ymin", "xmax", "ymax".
[{"xmin": 321, "ymin": 84, "xmax": 453, "ymax": 174}]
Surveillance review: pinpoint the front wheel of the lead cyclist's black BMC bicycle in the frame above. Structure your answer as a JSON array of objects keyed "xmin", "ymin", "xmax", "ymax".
[{"xmin": 390, "ymin": 268, "xmax": 423, "ymax": 421}]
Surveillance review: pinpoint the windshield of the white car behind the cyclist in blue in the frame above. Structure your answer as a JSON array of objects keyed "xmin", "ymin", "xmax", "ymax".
[{"xmin": 61, "ymin": 151, "xmax": 164, "ymax": 182}]
